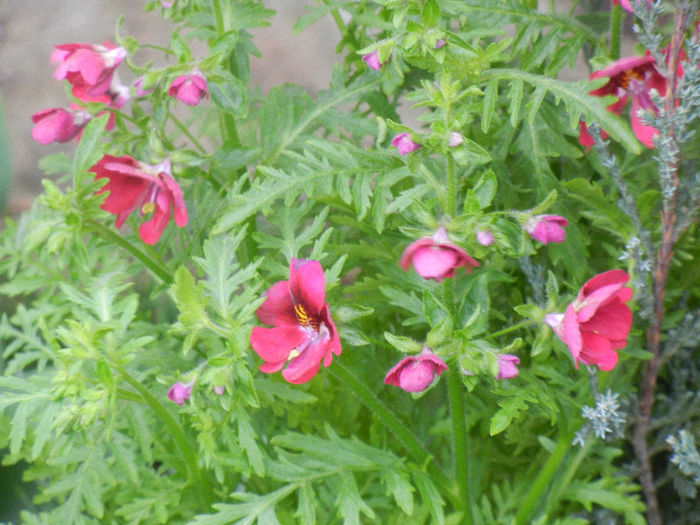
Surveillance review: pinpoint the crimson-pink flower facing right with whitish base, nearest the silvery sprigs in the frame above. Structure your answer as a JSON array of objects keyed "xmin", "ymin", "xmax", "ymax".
[{"xmin": 545, "ymin": 270, "xmax": 632, "ymax": 370}]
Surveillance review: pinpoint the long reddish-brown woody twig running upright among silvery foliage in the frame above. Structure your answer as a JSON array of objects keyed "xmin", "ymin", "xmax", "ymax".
[{"xmin": 632, "ymin": 4, "xmax": 689, "ymax": 525}]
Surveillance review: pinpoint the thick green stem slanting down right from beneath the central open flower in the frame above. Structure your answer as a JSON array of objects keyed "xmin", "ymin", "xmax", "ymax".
[{"xmin": 328, "ymin": 359, "xmax": 457, "ymax": 503}]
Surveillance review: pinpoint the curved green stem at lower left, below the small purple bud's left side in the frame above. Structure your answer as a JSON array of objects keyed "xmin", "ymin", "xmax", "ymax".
[{"xmin": 113, "ymin": 365, "xmax": 214, "ymax": 509}]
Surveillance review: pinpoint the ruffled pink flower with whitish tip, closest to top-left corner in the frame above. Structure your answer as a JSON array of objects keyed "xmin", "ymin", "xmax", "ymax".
[{"xmin": 51, "ymin": 42, "xmax": 126, "ymax": 100}]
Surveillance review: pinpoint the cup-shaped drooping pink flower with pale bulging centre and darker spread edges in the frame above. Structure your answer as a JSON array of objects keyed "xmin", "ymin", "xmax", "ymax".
[{"xmin": 399, "ymin": 226, "xmax": 479, "ymax": 281}]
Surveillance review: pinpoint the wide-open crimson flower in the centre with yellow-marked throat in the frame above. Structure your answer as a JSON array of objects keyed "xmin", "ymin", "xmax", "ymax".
[{"xmin": 250, "ymin": 259, "xmax": 341, "ymax": 384}]
